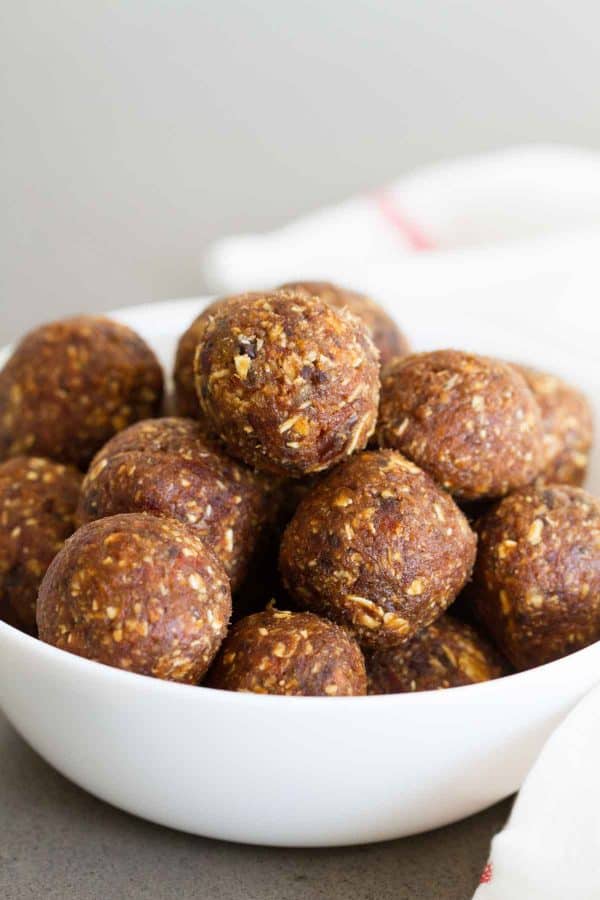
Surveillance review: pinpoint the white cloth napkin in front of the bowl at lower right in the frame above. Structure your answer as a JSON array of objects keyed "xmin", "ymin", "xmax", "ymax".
[{"xmin": 474, "ymin": 687, "xmax": 600, "ymax": 900}]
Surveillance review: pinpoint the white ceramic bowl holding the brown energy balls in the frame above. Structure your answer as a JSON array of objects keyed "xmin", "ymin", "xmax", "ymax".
[{"xmin": 0, "ymin": 300, "xmax": 600, "ymax": 846}]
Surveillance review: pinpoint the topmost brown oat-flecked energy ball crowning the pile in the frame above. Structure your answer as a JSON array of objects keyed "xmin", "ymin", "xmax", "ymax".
[{"xmin": 195, "ymin": 291, "xmax": 379, "ymax": 477}]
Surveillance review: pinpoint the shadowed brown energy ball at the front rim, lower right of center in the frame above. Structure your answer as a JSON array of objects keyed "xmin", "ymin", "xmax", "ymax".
[{"xmin": 367, "ymin": 615, "xmax": 508, "ymax": 694}]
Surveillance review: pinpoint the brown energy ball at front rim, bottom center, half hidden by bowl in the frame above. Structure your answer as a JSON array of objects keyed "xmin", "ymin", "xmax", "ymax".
[{"xmin": 206, "ymin": 609, "xmax": 367, "ymax": 697}]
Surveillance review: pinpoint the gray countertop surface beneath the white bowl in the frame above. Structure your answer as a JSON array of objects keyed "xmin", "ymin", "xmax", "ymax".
[{"xmin": 0, "ymin": 714, "xmax": 510, "ymax": 900}]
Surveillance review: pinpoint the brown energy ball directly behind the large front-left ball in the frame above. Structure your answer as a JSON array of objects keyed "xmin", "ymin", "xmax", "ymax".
[{"xmin": 78, "ymin": 418, "xmax": 274, "ymax": 590}]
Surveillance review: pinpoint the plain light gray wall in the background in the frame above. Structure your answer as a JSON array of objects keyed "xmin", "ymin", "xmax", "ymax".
[{"xmin": 0, "ymin": 0, "xmax": 600, "ymax": 342}]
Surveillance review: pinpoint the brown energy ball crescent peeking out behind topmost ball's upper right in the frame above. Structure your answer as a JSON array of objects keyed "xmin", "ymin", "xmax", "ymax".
[{"xmin": 282, "ymin": 281, "xmax": 410, "ymax": 366}]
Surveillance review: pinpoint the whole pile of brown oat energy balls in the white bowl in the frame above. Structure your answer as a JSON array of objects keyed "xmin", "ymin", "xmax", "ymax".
[{"xmin": 0, "ymin": 282, "xmax": 600, "ymax": 697}]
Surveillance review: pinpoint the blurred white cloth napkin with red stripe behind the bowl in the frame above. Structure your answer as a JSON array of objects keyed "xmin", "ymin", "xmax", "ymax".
[{"xmin": 202, "ymin": 145, "xmax": 600, "ymax": 360}]
